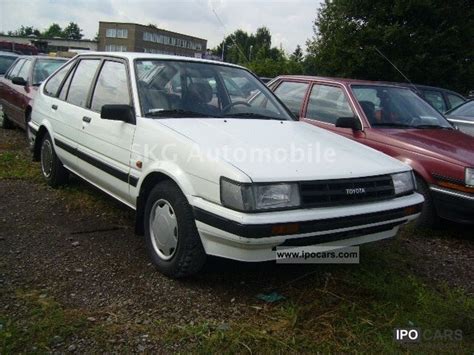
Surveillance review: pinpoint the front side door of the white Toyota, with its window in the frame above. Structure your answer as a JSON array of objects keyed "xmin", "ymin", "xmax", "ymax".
[{"xmin": 78, "ymin": 58, "xmax": 136, "ymax": 204}]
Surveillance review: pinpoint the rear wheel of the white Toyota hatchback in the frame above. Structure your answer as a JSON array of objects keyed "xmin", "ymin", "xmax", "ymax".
[{"xmin": 40, "ymin": 133, "xmax": 69, "ymax": 188}]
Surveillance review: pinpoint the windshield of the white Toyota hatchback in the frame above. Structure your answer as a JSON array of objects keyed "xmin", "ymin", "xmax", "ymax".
[{"xmin": 135, "ymin": 59, "xmax": 293, "ymax": 120}]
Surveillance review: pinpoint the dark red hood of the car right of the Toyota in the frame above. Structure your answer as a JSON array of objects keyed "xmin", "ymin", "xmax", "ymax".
[{"xmin": 384, "ymin": 129, "xmax": 474, "ymax": 167}]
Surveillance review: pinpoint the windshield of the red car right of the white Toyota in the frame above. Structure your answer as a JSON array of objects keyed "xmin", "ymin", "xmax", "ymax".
[{"xmin": 352, "ymin": 85, "xmax": 452, "ymax": 129}]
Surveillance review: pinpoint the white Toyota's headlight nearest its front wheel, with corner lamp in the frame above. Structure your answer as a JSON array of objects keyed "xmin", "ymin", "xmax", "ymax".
[{"xmin": 221, "ymin": 178, "xmax": 300, "ymax": 211}]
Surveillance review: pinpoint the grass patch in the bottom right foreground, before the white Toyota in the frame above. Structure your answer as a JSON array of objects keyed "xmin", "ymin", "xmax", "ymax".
[{"xmin": 167, "ymin": 247, "xmax": 474, "ymax": 353}]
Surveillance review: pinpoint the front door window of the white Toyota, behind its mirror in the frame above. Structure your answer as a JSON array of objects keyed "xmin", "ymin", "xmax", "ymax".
[{"xmin": 91, "ymin": 61, "xmax": 130, "ymax": 112}]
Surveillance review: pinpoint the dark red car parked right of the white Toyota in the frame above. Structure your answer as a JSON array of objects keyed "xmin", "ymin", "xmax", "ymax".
[{"xmin": 268, "ymin": 76, "xmax": 474, "ymax": 226}]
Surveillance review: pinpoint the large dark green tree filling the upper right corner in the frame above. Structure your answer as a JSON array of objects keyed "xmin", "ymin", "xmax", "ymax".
[{"xmin": 305, "ymin": 0, "xmax": 474, "ymax": 93}]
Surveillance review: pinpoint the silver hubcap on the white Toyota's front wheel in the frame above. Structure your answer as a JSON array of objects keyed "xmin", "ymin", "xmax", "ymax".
[{"xmin": 149, "ymin": 199, "xmax": 178, "ymax": 260}]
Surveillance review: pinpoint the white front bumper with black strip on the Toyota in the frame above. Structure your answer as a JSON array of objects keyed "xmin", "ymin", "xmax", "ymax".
[{"xmin": 192, "ymin": 193, "xmax": 423, "ymax": 261}]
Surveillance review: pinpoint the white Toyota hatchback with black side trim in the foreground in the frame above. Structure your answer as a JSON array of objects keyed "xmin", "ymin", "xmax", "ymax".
[{"xmin": 29, "ymin": 52, "xmax": 423, "ymax": 277}]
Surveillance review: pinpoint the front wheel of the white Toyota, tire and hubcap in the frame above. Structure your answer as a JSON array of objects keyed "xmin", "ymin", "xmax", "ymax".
[{"xmin": 144, "ymin": 181, "xmax": 206, "ymax": 278}]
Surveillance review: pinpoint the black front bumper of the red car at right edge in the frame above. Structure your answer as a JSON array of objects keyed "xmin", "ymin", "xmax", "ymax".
[{"xmin": 430, "ymin": 185, "xmax": 474, "ymax": 224}]
